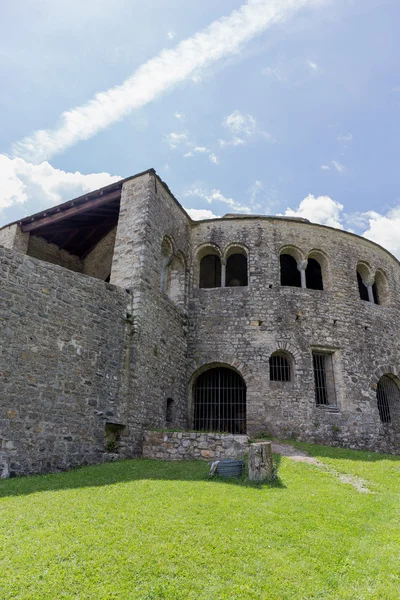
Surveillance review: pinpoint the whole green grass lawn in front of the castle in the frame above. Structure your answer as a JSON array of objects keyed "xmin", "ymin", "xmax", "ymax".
[{"xmin": 0, "ymin": 444, "xmax": 400, "ymax": 600}]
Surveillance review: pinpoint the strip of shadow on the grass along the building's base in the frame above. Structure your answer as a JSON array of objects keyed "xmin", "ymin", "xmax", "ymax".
[{"xmin": 0, "ymin": 455, "xmax": 286, "ymax": 499}]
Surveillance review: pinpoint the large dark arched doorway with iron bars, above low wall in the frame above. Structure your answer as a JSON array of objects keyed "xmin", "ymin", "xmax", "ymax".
[{"xmin": 193, "ymin": 367, "xmax": 246, "ymax": 434}]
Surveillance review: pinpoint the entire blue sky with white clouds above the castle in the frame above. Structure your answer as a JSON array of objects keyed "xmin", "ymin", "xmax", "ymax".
[{"xmin": 0, "ymin": 0, "xmax": 400, "ymax": 256}]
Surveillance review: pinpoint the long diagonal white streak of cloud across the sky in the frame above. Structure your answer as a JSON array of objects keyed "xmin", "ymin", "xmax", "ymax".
[{"xmin": 13, "ymin": 0, "xmax": 325, "ymax": 163}]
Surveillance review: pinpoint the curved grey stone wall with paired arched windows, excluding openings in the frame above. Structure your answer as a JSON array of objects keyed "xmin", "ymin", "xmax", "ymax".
[{"xmin": 188, "ymin": 218, "xmax": 400, "ymax": 452}]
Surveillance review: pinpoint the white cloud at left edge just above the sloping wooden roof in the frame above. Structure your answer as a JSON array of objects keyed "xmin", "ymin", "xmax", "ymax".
[{"xmin": 0, "ymin": 154, "xmax": 121, "ymax": 221}]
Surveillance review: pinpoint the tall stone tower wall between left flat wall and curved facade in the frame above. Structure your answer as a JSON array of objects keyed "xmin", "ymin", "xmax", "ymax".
[{"xmin": 111, "ymin": 172, "xmax": 190, "ymax": 451}]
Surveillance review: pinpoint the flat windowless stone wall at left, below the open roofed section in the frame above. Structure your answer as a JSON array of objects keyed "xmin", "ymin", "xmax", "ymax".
[{"xmin": 0, "ymin": 247, "xmax": 133, "ymax": 475}]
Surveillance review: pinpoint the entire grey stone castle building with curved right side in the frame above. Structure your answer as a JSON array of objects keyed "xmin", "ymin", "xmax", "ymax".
[{"xmin": 0, "ymin": 169, "xmax": 400, "ymax": 474}]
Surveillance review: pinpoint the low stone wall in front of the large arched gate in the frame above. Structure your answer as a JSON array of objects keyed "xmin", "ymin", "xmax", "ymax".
[{"xmin": 143, "ymin": 431, "xmax": 249, "ymax": 460}]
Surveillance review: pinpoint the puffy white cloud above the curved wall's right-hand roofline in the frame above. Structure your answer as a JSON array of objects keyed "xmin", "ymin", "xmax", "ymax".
[{"xmin": 284, "ymin": 194, "xmax": 343, "ymax": 229}]
